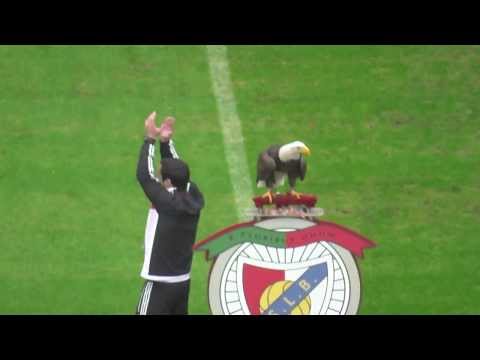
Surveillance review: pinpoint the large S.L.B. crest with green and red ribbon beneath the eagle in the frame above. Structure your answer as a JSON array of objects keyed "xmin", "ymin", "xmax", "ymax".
[{"xmin": 194, "ymin": 196, "xmax": 375, "ymax": 315}]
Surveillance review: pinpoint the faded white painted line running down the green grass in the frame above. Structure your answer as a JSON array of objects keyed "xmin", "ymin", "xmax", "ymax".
[{"xmin": 207, "ymin": 46, "xmax": 252, "ymax": 219}]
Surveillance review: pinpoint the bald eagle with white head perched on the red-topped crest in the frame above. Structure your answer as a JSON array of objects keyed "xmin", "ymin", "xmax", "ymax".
[{"xmin": 257, "ymin": 141, "xmax": 310, "ymax": 203}]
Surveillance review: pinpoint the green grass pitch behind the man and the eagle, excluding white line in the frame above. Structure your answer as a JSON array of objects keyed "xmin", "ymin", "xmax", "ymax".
[{"xmin": 0, "ymin": 46, "xmax": 480, "ymax": 314}]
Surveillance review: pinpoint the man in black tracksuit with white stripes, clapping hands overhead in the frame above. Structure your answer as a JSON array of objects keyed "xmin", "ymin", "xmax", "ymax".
[{"xmin": 136, "ymin": 113, "xmax": 204, "ymax": 315}]
